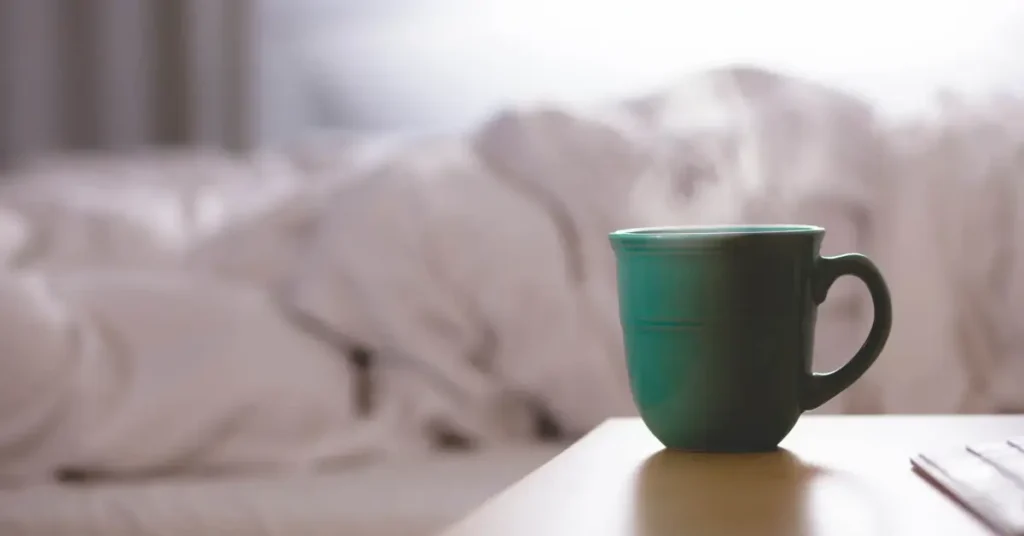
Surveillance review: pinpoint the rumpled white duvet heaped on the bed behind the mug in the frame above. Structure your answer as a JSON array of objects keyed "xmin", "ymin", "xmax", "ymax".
[{"xmin": 0, "ymin": 69, "xmax": 1024, "ymax": 482}]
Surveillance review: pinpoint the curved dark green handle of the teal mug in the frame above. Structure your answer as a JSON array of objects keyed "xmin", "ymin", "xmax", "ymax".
[{"xmin": 801, "ymin": 253, "xmax": 893, "ymax": 411}]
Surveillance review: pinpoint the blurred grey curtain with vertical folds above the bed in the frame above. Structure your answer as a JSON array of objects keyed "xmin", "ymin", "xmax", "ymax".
[{"xmin": 0, "ymin": 0, "xmax": 257, "ymax": 168}]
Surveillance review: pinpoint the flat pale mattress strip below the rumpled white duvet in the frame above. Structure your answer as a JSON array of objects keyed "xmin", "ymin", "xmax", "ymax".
[{"xmin": 0, "ymin": 445, "xmax": 561, "ymax": 536}]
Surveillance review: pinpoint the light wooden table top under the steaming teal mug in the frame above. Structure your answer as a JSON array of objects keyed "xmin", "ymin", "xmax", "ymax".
[{"xmin": 443, "ymin": 416, "xmax": 1024, "ymax": 536}]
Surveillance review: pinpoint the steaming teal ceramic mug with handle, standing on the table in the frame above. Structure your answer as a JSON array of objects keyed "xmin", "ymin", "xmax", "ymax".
[{"xmin": 609, "ymin": 225, "xmax": 892, "ymax": 452}]
